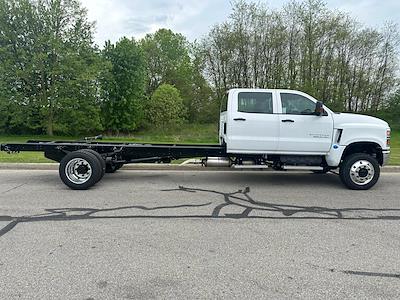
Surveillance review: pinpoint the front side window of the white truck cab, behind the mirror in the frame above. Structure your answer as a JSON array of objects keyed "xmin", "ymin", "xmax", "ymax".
[{"xmin": 281, "ymin": 93, "xmax": 315, "ymax": 115}]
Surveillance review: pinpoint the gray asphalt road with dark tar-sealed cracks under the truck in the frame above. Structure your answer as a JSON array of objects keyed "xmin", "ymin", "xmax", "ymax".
[{"xmin": 0, "ymin": 170, "xmax": 400, "ymax": 299}]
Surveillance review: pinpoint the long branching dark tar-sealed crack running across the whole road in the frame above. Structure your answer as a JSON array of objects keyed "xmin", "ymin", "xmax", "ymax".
[{"xmin": 0, "ymin": 186, "xmax": 400, "ymax": 237}]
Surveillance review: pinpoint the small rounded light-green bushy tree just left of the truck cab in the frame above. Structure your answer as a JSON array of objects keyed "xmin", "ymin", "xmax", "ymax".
[{"xmin": 146, "ymin": 84, "xmax": 185, "ymax": 128}]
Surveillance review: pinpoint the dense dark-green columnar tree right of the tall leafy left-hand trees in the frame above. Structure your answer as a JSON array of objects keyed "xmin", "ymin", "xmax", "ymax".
[{"xmin": 101, "ymin": 38, "xmax": 145, "ymax": 133}]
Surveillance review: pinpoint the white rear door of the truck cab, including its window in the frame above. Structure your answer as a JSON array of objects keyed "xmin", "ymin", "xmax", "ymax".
[{"xmin": 227, "ymin": 90, "xmax": 279, "ymax": 153}]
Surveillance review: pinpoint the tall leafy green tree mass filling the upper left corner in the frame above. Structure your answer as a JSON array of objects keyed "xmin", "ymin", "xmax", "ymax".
[{"xmin": 0, "ymin": 0, "xmax": 101, "ymax": 135}]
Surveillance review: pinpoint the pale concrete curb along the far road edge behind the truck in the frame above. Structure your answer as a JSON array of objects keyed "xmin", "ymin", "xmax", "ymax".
[{"xmin": 0, "ymin": 163, "xmax": 400, "ymax": 173}]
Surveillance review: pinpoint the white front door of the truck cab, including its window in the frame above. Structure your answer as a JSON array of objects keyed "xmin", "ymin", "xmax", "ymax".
[{"xmin": 278, "ymin": 92, "xmax": 333, "ymax": 153}]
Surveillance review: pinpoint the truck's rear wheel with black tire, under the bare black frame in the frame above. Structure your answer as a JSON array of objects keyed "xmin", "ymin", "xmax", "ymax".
[{"xmin": 59, "ymin": 151, "xmax": 102, "ymax": 190}]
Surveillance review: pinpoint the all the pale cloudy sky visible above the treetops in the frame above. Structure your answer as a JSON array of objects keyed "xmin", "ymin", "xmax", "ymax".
[{"xmin": 81, "ymin": 0, "xmax": 400, "ymax": 46}]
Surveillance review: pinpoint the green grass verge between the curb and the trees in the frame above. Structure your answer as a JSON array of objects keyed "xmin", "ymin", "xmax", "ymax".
[{"xmin": 0, "ymin": 124, "xmax": 400, "ymax": 165}]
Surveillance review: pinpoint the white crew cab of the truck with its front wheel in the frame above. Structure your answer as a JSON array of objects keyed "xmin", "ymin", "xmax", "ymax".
[{"xmin": 219, "ymin": 89, "xmax": 390, "ymax": 189}]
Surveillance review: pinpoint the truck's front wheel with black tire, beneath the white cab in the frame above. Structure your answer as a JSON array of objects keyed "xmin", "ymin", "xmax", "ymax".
[{"xmin": 339, "ymin": 153, "xmax": 380, "ymax": 190}]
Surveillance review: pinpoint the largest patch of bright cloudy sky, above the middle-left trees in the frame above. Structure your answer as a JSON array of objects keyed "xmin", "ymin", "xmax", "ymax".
[{"xmin": 82, "ymin": 0, "xmax": 230, "ymax": 45}]
